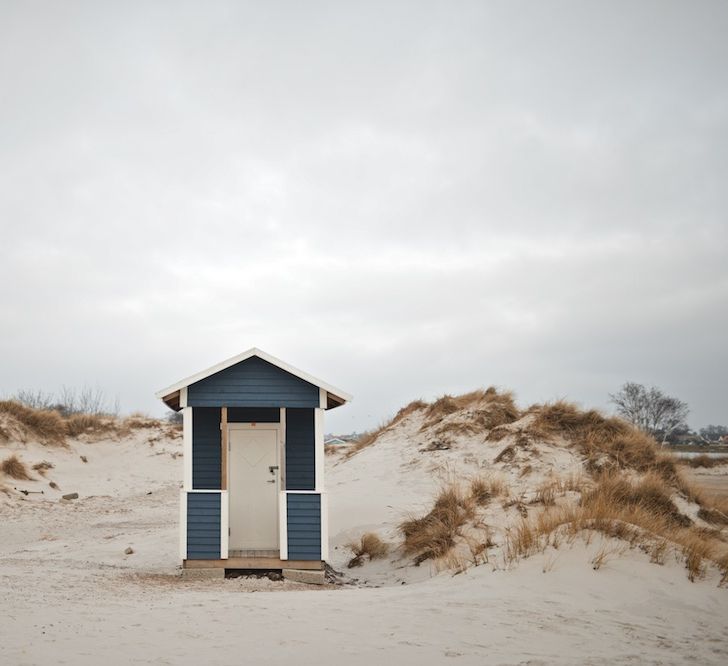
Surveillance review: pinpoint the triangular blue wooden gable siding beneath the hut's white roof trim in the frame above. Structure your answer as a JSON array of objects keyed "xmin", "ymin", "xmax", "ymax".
[{"xmin": 187, "ymin": 356, "xmax": 319, "ymax": 407}]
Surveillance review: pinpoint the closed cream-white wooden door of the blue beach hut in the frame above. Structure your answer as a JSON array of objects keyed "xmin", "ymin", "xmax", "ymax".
[{"xmin": 228, "ymin": 427, "xmax": 279, "ymax": 550}]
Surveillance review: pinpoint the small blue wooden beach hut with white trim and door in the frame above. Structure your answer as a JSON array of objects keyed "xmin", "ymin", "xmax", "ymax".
[{"xmin": 156, "ymin": 348, "xmax": 351, "ymax": 579}]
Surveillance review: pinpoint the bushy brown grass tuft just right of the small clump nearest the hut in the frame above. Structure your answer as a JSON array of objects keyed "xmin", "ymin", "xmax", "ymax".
[{"xmin": 399, "ymin": 485, "xmax": 474, "ymax": 565}]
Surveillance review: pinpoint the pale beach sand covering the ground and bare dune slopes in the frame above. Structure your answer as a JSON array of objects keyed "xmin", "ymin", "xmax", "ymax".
[{"xmin": 0, "ymin": 416, "xmax": 728, "ymax": 666}]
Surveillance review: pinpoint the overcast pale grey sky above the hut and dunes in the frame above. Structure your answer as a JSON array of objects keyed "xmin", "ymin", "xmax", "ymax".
[{"xmin": 0, "ymin": 0, "xmax": 728, "ymax": 432}]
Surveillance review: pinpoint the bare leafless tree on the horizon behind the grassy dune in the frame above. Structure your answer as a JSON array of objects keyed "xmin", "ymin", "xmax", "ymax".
[{"xmin": 609, "ymin": 382, "xmax": 690, "ymax": 444}]
